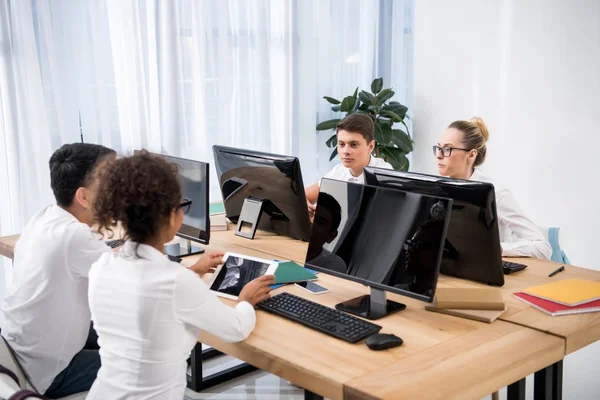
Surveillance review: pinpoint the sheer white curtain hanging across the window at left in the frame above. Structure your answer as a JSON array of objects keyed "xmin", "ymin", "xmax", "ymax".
[{"xmin": 0, "ymin": 0, "xmax": 413, "ymax": 292}]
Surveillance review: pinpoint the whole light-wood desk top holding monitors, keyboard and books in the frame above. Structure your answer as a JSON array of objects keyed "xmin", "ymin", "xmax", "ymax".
[{"xmin": 0, "ymin": 230, "xmax": 600, "ymax": 399}]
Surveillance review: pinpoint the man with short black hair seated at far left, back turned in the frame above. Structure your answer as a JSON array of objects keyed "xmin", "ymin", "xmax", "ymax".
[{"xmin": 1, "ymin": 143, "xmax": 115, "ymax": 398}]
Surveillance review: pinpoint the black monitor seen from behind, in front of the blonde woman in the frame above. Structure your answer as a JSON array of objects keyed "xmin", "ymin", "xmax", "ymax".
[{"xmin": 364, "ymin": 167, "xmax": 504, "ymax": 286}]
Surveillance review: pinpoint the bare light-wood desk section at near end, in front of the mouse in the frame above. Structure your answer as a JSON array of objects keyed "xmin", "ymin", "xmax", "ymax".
[{"xmin": 344, "ymin": 321, "xmax": 564, "ymax": 400}]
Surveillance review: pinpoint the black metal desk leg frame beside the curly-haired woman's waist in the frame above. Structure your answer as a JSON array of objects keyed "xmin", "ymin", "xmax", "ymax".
[{"xmin": 187, "ymin": 343, "xmax": 258, "ymax": 392}]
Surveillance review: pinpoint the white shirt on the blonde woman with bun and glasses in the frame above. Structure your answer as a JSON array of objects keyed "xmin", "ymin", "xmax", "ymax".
[{"xmin": 470, "ymin": 169, "xmax": 552, "ymax": 260}]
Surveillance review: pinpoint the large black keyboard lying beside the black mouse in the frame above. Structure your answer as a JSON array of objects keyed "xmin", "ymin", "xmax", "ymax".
[{"xmin": 258, "ymin": 293, "xmax": 381, "ymax": 343}]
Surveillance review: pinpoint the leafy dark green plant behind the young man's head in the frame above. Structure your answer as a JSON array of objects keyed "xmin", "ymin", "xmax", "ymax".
[{"xmin": 317, "ymin": 78, "xmax": 414, "ymax": 171}]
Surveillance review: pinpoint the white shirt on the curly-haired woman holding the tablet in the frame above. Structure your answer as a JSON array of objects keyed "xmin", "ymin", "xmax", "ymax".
[{"xmin": 87, "ymin": 242, "xmax": 256, "ymax": 400}]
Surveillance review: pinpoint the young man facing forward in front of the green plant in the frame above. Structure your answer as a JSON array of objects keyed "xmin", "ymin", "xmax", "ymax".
[{"xmin": 306, "ymin": 113, "xmax": 392, "ymax": 218}]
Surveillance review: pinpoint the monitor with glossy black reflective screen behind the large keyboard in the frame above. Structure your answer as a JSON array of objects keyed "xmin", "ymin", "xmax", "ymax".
[{"xmin": 305, "ymin": 179, "xmax": 452, "ymax": 319}]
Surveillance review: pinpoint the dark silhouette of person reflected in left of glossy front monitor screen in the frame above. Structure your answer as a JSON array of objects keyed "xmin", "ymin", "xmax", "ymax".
[{"xmin": 306, "ymin": 192, "xmax": 348, "ymax": 273}]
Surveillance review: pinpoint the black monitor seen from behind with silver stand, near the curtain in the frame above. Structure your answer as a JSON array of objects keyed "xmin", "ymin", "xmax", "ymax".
[{"xmin": 213, "ymin": 146, "xmax": 311, "ymax": 241}]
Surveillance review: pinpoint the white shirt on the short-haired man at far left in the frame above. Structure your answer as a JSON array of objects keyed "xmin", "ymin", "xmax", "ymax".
[{"xmin": 1, "ymin": 205, "xmax": 111, "ymax": 393}]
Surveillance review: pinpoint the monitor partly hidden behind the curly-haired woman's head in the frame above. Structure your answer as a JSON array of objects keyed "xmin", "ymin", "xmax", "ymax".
[{"xmin": 136, "ymin": 151, "xmax": 210, "ymax": 257}]
